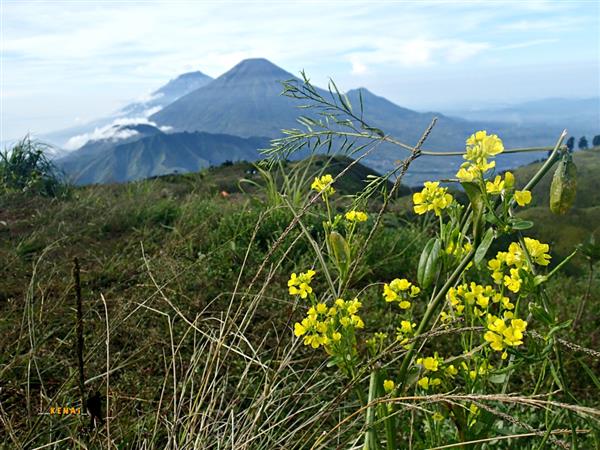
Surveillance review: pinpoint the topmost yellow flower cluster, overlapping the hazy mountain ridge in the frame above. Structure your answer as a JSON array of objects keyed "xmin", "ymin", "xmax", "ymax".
[{"xmin": 456, "ymin": 131, "xmax": 504, "ymax": 181}]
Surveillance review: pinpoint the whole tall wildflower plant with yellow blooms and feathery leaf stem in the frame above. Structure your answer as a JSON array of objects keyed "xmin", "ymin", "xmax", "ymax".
[{"xmin": 264, "ymin": 69, "xmax": 592, "ymax": 450}]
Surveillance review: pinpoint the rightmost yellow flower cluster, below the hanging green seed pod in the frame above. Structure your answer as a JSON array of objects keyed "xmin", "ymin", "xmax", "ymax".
[{"xmin": 488, "ymin": 237, "xmax": 551, "ymax": 293}]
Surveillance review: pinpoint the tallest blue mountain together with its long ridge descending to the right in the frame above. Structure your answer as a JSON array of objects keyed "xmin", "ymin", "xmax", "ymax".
[{"xmin": 149, "ymin": 59, "xmax": 562, "ymax": 184}]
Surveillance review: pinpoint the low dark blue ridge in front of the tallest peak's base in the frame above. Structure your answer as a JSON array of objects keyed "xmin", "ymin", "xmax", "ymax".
[{"xmin": 56, "ymin": 125, "xmax": 269, "ymax": 184}]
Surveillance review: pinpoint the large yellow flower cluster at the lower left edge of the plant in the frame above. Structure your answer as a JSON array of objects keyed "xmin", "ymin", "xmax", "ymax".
[{"xmin": 294, "ymin": 298, "xmax": 365, "ymax": 353}]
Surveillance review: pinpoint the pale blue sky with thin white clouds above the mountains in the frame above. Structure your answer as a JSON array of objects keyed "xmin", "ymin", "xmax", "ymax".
[{"xmin": 0, "ymin": 0, "xmax": 600, "ymax": 140}]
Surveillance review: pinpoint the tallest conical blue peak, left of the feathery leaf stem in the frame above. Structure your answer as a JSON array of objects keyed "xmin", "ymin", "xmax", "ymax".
[{"xmin": 150, "ymin": 59, "xmax": 312, "ymax": 137}]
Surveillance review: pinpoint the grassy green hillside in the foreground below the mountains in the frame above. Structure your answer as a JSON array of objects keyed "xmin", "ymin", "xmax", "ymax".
[{"xmin": 0, "ymin": 156, "xmax": 600, "ymax": 449}]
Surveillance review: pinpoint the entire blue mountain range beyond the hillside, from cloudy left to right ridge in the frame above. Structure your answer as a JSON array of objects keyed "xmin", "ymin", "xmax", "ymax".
[{"xmin": 52, "ymin": 58, "xmax": 596, "ymax": 185}]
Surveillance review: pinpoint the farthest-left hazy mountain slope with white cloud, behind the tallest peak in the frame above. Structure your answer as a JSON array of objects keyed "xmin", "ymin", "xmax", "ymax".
[{"xmin": 39, "ymin": 71, "xmax": 212, "ymax": 150}]
